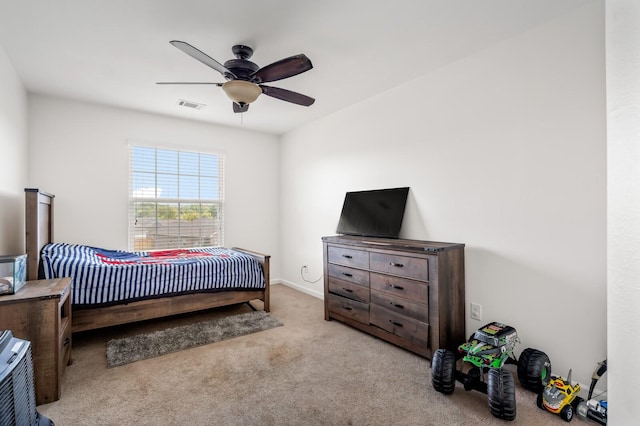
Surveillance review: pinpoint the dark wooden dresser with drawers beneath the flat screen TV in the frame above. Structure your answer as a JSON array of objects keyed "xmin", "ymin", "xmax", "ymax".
[{"xmin": 322, "ymin": 236, "xmax": 465, "ymax": 358}]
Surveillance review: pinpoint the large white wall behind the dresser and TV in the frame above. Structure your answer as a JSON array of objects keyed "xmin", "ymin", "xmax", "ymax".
[{"xmin": 281, "ymin": 2, "xmax": 606, "ymax": 382}]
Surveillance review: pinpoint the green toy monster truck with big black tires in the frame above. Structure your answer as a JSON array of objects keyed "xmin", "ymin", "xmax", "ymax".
[{"xmin": 431, "ymin": 322, "xmax": 551, "ymax": 420}]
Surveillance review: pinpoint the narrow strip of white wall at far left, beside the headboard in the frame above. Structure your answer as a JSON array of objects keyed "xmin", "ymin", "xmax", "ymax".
[{"xmin": 0, "ymin": 46, "xmax": 29, "ymax": 255}]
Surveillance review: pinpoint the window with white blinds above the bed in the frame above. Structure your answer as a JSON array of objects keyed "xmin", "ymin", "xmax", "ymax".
[{"xmin": 129, "ymin": 146, "xmax": 224, "ymax": 251}]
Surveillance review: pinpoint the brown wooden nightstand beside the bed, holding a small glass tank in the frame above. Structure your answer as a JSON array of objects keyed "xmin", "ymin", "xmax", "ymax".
[{"xmin": 0, "ymin": 278, "xmax": 71, "ymax": 405}]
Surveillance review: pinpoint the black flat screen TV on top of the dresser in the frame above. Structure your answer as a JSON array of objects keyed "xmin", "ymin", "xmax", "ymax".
[{"xmin": 336, "ymin": 187, "xmax": 409, "ymax": 238}]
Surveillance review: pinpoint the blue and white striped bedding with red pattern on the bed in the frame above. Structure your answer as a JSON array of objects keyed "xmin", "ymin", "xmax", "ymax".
[{"xmin": 41, "ymin": 243, "xmax": 265, "ymax": 307}]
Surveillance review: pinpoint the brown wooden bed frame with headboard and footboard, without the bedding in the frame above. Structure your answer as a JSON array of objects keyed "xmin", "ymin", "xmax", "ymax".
[{"xmin": 25, "ymin": 188, "xmax": 270, "ymax": 332}]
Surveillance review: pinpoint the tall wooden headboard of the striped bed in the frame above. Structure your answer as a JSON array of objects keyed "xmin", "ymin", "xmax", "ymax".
[{"xmin": 24, "ymin": 188, "xmax": 54, "ymax": 280}]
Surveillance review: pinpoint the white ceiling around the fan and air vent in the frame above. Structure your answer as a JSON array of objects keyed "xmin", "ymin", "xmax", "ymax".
[{"xmin": 0, "ymin": 0, "xmax": 590, "ymax": 134}]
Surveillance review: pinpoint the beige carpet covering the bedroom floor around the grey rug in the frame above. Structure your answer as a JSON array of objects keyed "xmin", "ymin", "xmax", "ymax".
[{"xmin": 38, "ymin": 285, "xmax": 564, "ymax": 426}]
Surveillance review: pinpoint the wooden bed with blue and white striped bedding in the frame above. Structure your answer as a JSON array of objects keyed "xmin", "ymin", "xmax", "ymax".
[{"xmin": 25, "ymin": 188, "xmax": 270, "ymax": 332}]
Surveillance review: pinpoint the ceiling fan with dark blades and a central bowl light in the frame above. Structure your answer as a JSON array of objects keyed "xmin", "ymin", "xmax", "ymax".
[{"xmin": 157, "ymin": 40, "xmax": 315, "ymax": 112}]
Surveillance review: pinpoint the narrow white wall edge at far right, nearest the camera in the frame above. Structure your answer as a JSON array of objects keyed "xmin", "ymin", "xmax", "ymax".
[{"xmin": 606, "ymin": 0, "xmax": 640, "ymax": 425}]
